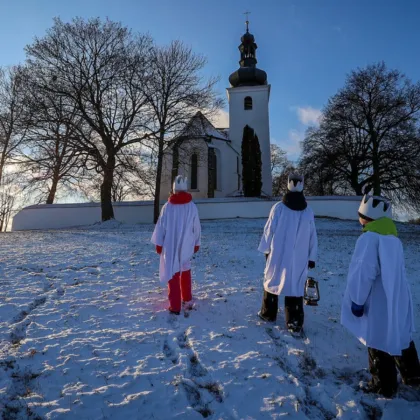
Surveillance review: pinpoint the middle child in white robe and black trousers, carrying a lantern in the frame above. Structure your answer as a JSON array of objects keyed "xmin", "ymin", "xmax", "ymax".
[{"xmin": 258, "ymin": 174, "xmax": 318, "ymax": 333}]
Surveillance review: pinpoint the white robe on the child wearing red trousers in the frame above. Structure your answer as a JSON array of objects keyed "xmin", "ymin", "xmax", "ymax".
[{"xmin": 152, "ymin": 202, "xmax": 201, "ymax": 283}]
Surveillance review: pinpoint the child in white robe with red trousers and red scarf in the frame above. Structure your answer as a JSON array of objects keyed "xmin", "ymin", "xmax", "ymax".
[{"xmin": 152, "ymin": 175, "xmax": 201, "ymax": 315}]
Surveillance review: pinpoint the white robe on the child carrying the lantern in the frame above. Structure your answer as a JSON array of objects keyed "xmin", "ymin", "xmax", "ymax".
[{"xmin": 258, "ymin": 203, "xmax": 318, "ymax": 297}]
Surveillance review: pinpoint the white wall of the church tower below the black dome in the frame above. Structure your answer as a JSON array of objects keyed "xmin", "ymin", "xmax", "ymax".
[{"xmin": 227, "ymin": 85, "xmax": 272, "ymax": 195}]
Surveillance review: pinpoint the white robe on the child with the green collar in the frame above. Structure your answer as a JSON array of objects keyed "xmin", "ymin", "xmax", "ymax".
[{"xmin": 341, "ymin": 232, "xmax": 414, "ymax": 356}]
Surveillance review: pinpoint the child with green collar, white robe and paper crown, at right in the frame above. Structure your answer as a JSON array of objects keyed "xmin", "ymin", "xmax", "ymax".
[{"xmin": 341, "ymin": 195, "xmax": 420, "ymax": 397}]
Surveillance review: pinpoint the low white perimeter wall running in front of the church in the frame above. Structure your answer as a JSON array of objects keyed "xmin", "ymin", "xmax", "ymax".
[{"xmin": 12, "ymin": 197, "xmax": 361, "ymax": 231}]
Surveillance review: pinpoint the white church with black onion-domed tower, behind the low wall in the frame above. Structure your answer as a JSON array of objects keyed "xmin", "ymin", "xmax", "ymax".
[{"xmin": 160, "ymin": 21, "xmax": 272, "ymax": 201}]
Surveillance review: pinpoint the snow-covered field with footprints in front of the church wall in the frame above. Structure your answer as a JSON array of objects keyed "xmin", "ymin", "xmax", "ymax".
[{"xmin": 0, "ymin": 219, "xmax": 420, "ymax": 420}]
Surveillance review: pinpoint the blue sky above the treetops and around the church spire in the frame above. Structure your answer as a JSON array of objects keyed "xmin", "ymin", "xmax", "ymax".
[{"xmin": 0, "ymin": 0, "xmax": 420, "ymax": 158}]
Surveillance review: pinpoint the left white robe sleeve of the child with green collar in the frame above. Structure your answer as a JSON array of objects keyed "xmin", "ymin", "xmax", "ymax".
[{"xmin": 347, "ymin": 233, "xmax": 380, "ymax": 305}]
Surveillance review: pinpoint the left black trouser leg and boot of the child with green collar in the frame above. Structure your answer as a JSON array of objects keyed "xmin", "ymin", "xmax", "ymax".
[{"xmin": 363, "ymin": 347, "xmax": 398, "ymax": 398}]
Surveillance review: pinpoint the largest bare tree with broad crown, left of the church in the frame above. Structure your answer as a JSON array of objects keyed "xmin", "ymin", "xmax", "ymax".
[{"xmin": 26, "ymin": 18, "xmax": 151, "ymax": 221}]
